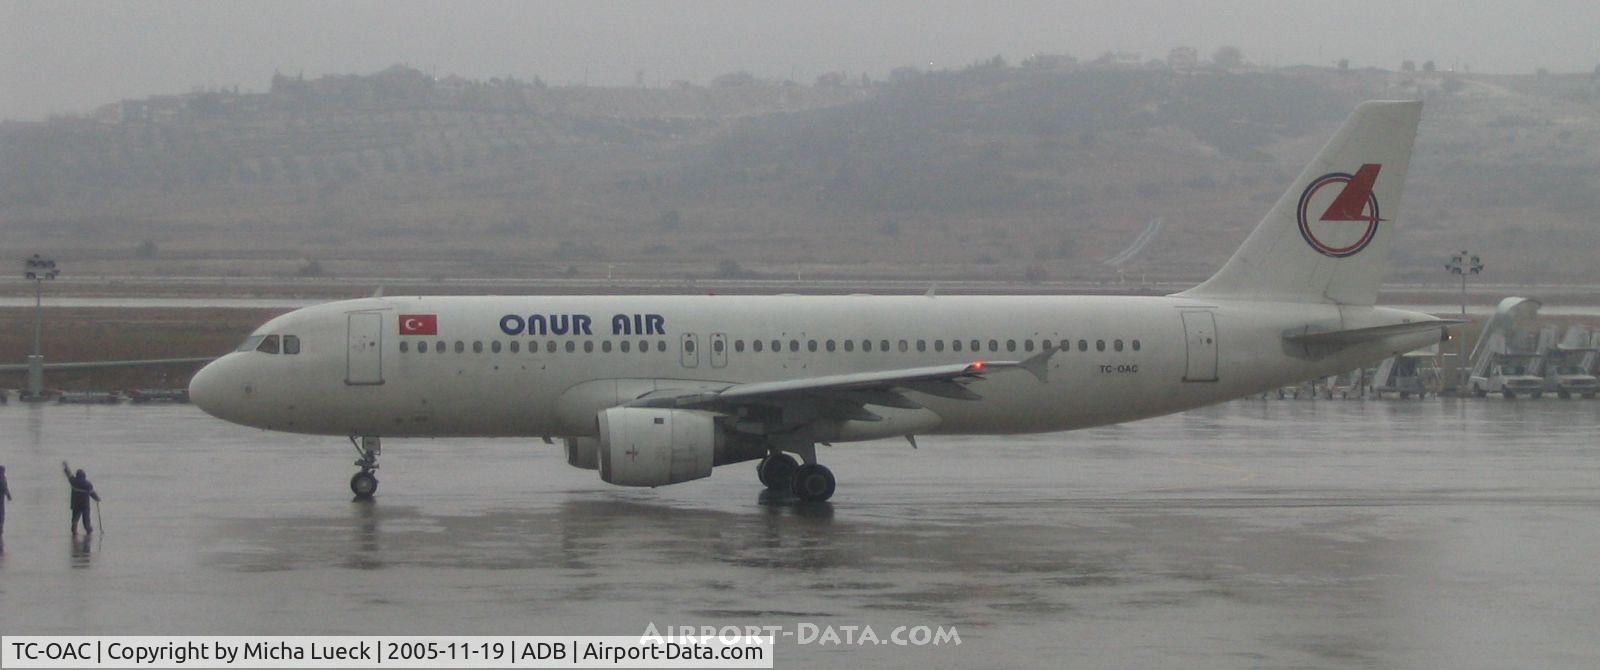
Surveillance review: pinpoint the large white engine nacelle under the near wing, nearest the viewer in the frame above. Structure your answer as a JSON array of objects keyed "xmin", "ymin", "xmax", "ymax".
[{"xmin": 597, "ymin": 408, "xmax": 717, "ymax": 486}]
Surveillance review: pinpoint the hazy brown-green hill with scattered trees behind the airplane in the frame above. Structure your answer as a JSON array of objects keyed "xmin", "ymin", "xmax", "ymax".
[{"xmin": 0, "ymin": 59, "xmax": 1600, "ymax": 283}]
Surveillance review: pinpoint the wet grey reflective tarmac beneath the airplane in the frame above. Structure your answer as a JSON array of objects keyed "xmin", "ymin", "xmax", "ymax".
[{"xmin": 0, "ymin": 398, "xmax": 1600, "ymax": 668}]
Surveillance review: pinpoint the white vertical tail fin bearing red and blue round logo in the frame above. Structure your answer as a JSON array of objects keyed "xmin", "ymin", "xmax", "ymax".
[{"xmin": 1179, "ymin": 101, "xmax": 1422, "ymax": 305}]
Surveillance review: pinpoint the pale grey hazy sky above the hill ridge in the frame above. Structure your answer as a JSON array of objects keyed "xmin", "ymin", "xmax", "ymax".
[{"xmin": 0, "ymin": 0, "xmax": 1600, "ymax": 118}]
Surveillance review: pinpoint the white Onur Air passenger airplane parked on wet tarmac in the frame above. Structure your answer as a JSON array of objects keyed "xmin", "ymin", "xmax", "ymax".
[{"xmin": 189, "ymin": 101, "xmax": 1462, "ymax": 502}]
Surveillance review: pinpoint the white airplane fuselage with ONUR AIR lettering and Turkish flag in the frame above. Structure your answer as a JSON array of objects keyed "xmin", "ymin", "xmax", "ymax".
[{"xmin": 190, "ymin": 296, "xmax": 1438, "ymax": 441}]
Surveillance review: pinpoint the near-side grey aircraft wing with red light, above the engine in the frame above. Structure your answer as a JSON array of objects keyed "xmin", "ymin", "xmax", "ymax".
[{"xmin": 624, "ymin": 349, "xmax": 1056, "ymax": 421}]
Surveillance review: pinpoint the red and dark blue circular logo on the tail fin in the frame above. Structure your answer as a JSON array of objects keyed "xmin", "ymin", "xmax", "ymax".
[{"xmin": 1294, "ymin": 163, "xmax": 1384, "ymax": 257}]
